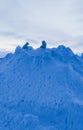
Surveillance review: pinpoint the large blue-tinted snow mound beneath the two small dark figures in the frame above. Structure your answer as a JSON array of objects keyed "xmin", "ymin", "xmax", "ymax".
[{"xmin": 0, "ymin": 45, "xmax": 83, "ymax": 130}]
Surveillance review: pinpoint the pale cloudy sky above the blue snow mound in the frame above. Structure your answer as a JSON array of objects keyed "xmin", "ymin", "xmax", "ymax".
[{"xmin": 0, "ymin": 0, "xmax": 83, "ymax": 53}]
